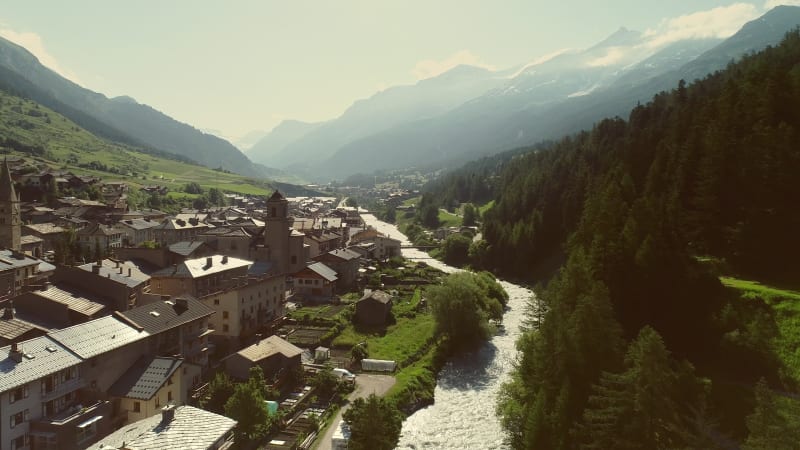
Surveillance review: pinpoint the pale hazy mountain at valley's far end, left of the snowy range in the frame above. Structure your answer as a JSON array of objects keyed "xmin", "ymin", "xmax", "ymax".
[{"xmin": 248, "ymin": 65, "xmax": 506, "ymax": 171}]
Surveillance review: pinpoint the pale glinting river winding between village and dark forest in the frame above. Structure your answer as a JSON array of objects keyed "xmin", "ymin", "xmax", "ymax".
[{"xmin": 362, "ymin": 214, "xmax": 532, "ymax": 450}]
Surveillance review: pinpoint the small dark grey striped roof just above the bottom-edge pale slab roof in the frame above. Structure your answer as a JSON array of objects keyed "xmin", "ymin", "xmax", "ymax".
[{"xmin": 108, "ymin": 357, "xmax": 183, "ymax": 400}]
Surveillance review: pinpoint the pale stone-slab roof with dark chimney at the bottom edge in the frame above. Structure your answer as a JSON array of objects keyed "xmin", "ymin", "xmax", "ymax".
[{"xmin": 88, "ymin": 405, "xmax": 236, "ymax": 450}]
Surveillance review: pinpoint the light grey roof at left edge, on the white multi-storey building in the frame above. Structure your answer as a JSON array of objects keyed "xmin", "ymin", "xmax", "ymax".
[{"xmin": 0, "ymin": 336, "xmax": 81, "ymax": 392}]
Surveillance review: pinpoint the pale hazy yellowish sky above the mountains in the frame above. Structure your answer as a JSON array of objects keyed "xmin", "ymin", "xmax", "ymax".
[{"xmin": 0, "ymin": 0, "xmax": 800, "ymax": 141}]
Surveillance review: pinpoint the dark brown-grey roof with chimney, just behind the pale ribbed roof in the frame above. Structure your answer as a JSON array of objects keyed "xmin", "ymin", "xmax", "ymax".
[{"xmin": 115, "ymin": 295, "xmax": 214, "ymax": 334}]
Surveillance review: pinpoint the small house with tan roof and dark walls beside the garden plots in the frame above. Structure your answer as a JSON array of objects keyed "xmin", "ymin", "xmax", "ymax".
[{"xmin": 224, "ymin": 336, "xmax": 303, "ymax": 380}]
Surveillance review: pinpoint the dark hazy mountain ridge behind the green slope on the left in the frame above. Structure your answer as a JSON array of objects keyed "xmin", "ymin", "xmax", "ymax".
[{"xmin": 0, "ymin": 38, "xmax": 270, "ymax": 177}]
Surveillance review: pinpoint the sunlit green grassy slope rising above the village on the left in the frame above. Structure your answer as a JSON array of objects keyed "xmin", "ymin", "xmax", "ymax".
[{"xmin": 0, "ymin": 91, "xmax": 272, "ymax": 194}]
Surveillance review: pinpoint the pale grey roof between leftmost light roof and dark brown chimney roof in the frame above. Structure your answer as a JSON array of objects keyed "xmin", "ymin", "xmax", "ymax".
[{"xmin": 49, "ymin": 316, "xmax": 150, "ymax": 359}]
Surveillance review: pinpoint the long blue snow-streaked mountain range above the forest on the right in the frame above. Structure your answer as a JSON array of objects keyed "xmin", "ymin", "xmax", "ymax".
[{"xmin": 288, "ymin": 6, "xmax": 800, "ymax": 179}]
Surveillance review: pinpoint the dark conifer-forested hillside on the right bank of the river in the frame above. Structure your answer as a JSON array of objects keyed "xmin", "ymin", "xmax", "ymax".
[{"xmin": 474, "ymin": 31, "xmax": 800, "ymax": 449}]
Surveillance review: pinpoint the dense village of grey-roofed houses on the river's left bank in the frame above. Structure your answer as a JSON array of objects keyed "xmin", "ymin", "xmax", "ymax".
[{"xmin": 0, "ymin": 156, "xmax": 444, "ymax": 449}]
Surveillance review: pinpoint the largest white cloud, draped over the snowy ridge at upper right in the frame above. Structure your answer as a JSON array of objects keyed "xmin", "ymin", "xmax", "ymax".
[{"xmin": 645, "ymin": 0, "xmax": 764, "ymax": 47}]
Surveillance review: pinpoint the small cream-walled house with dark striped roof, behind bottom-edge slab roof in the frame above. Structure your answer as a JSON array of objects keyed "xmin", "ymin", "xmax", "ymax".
[{"xmin": 108, "ymin": 357, "xmax": 186, "ymax": 423}]
